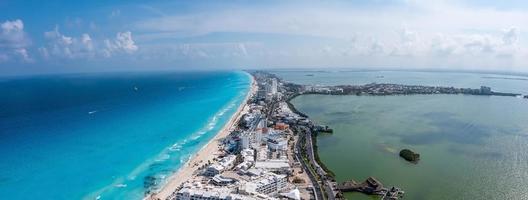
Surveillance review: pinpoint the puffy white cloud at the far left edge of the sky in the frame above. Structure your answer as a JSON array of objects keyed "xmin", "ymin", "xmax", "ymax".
[{"xmin": 0, "ymin": 19, "xmax": 32, "ymax": 62}]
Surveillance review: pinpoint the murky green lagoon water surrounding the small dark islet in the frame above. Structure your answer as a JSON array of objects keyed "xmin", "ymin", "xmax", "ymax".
[{"xmin": 292, "ymin": 95, "xmax": 528, "ymax": 199}]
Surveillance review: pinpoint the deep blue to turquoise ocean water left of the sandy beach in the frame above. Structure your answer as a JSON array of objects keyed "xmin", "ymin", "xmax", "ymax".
[{"xmin": 0, "ymin": 72, "xmax": 250, "ymax": 199}]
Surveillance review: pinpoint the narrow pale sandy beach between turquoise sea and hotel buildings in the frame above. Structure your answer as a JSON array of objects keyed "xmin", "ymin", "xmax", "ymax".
[{"xmin": 150, "ymin": 72, "xmax": 257, "ymax": 200}]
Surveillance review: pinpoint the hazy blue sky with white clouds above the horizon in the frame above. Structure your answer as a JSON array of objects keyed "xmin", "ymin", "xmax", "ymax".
[{"xmin": 0, "ymin": 0, "xmax": 528, "ymax": 75}]
